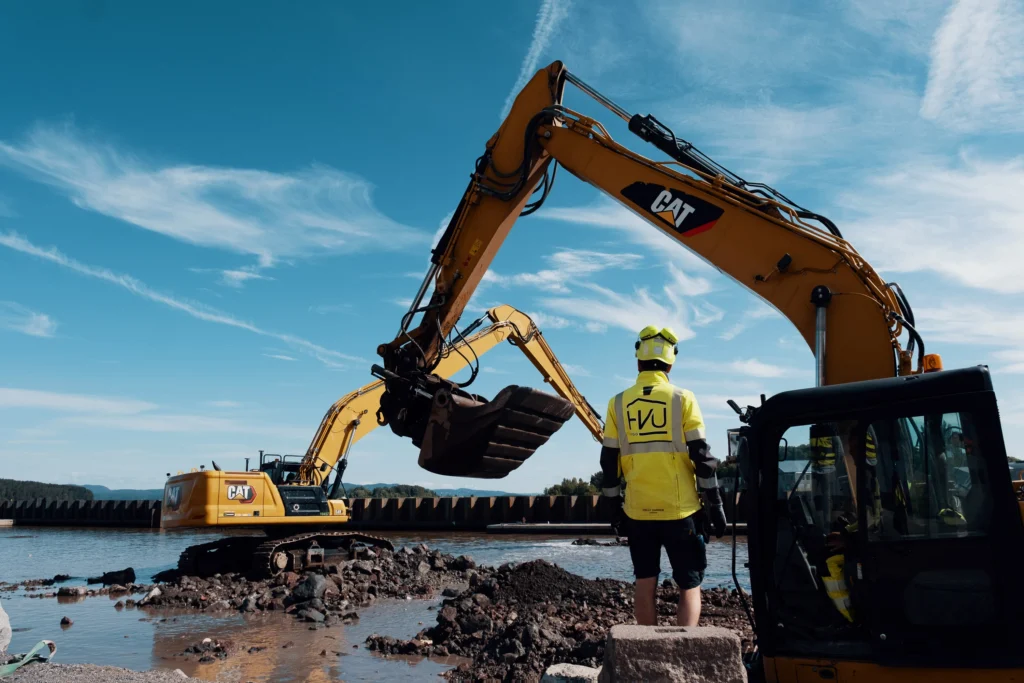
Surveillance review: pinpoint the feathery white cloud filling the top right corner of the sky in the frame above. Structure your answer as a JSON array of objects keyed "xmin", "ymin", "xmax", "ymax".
[{"xmin": 921, "ymin": 0, "xmax": 1024, "ymax": 131}]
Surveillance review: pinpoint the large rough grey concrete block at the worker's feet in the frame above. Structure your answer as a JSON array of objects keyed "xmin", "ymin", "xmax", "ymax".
[{"xmin": 599, "ymin": 625, "xmax": 746, "ymax": 683}]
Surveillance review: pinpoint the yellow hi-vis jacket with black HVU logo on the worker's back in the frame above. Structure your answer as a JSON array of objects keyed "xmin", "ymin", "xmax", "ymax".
[{"xmin": 604, "ymin": 372, "xmax": 706, "ymax": 520}]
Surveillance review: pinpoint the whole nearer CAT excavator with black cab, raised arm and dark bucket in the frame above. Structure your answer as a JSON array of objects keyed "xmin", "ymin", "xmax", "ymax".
[{"xmin": 372, "ymin": 61, "xmax": 1024, "ymax": 683}]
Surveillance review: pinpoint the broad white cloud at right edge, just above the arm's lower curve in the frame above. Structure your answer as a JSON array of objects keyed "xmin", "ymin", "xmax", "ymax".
[{"xmin": 838, "ymin": 154, "xmax": 1024, "ymax": 293}]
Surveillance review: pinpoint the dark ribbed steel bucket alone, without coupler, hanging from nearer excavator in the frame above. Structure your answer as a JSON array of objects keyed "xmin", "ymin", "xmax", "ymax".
[{"xmin": 419, "ymin": 385, "xmax": 573, "ymax": 479}]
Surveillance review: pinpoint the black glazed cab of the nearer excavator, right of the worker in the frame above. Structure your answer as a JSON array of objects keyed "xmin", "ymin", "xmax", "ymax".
[{"xmin": 739, "ymin": 367, "xmax": 1024, "ymax": 681}]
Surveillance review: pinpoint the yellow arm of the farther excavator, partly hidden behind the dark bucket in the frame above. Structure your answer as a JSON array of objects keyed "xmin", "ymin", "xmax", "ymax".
[{"xmin": 295, "ymin": 305, "xmax": 604, "ymax": 485}]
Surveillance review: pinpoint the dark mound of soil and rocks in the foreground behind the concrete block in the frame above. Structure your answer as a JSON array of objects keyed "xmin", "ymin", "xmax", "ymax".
[{"xmin": 367, "ymin": 560, "xmax": 752, "ymax": 681}]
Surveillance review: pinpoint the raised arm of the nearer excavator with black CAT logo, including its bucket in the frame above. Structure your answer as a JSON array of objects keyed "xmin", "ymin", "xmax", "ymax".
[{"xmin": 373, "ymin": 61, "xmax": 924, "ymax": 478}]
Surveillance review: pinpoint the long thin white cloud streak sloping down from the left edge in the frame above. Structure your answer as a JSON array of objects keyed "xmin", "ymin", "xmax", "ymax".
[{"xmin": 0, "ymin": 232, "xmax": 366, "ymax": 368}]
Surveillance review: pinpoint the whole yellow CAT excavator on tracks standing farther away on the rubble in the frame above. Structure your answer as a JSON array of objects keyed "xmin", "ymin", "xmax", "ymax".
[{"xmin": 160, "ymin": 305, "xmax": 604, "ymax": 577}]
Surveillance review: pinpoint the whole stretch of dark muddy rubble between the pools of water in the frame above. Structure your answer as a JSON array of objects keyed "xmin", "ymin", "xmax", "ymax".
[{"xmin": 0, "ymin": 545, "xmax": 752, "ymax": 681}]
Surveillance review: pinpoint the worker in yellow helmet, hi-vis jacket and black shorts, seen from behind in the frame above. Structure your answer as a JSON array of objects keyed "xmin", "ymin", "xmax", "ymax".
[{"xmin": 601, "ymin": 326, "xmax": 726, "ymax": 626}]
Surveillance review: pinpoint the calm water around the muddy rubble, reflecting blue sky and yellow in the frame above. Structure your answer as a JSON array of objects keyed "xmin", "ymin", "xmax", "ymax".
[{"xmin": 0, "ymin": 527, "xmax": 749, "ymax": 682}]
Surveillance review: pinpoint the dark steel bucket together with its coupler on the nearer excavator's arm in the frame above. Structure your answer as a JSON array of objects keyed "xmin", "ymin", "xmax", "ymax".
[{"xmin": 373, "ymin": 366, "xmax": 574, "ymax": 479}]
